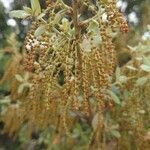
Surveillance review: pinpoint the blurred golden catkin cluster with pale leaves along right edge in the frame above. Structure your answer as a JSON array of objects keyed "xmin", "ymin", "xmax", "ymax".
[{"xmin": 112, "ymin": 40, "xmax": 150, "ymax": 149}]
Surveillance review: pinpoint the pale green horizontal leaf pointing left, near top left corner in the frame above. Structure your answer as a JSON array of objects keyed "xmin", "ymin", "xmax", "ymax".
[{"xmin": 10, "ymin": 10, "xmax": 31, "ymax": 19}]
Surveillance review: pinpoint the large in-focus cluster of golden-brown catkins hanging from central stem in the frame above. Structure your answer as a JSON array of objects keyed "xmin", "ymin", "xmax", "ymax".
[{"xmin": 1, "ymin": 0, "xmax": 128, "ymax": 139}]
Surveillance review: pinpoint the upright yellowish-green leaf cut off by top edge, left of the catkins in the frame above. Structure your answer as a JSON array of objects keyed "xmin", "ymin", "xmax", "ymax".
[{"xmin": 31, "ymin": 0, "xmax": 41, "ymax": 16}]
